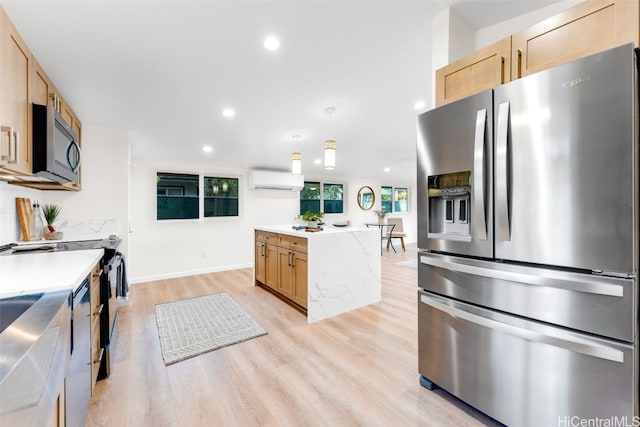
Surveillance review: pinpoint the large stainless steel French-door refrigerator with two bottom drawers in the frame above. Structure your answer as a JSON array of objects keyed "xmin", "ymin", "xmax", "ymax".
[{"xmin": 417, "ymin": 45, "xmax": 640, "ymax": 426}]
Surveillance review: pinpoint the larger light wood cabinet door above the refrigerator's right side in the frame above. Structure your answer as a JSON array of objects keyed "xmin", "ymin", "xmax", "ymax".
[{"xmin": 511, "ymin": 0, "xmax": 640, "ymax": 79}]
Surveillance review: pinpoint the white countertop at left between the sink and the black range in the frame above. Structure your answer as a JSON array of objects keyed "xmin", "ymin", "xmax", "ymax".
[{"xmin": 0, "ymin": 249, "xmax": 104, "ymax": 298}]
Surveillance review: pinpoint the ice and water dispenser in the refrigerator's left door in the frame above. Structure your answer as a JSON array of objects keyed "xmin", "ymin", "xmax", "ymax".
[{"xmin": 428, "ymin": 171, "xmax": 471, "ymax": 240}]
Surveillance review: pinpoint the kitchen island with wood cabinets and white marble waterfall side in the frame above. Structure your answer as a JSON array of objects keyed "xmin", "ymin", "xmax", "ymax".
[{"xmin": 254, "ymin": 225, "xmax": 382, "ymax": 323}]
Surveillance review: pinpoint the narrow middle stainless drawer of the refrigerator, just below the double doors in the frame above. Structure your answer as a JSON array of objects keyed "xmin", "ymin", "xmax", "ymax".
[{"xmin": 418, "ymin": 252, "xmax": 638, "ymax": 342}]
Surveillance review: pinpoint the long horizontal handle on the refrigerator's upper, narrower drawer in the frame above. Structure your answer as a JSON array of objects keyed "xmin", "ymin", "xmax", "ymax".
[{"xmin": 420, "ymin": 254, "xmax": 624, "ymax": 298}]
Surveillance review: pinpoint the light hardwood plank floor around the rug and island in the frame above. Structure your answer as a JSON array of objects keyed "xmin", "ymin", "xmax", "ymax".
[{"xmin": 87, "ymin": 247, "xmax": 500, "ymax": 427}]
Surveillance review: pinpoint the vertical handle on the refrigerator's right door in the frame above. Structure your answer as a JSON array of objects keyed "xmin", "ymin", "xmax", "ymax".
[{"xmin": 496, "ymin": 102, "xmax": 511, "ymax": 242}]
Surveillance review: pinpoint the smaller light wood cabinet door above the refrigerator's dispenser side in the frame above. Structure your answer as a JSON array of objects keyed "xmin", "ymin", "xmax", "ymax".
[{"xmin": 436, "ymin": 37, "xmax": 511, "ymax": 106}]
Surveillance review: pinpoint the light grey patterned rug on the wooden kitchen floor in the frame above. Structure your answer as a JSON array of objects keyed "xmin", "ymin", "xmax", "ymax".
[{"xmin": 156, "ymin": 292, "xmax": 267, "ymax": 365}]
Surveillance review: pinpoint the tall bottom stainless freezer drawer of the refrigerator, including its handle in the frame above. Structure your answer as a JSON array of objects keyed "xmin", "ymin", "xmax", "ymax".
[{"xmin": 418, "ymin": 291, "xmax": 638, "ymax": 427}]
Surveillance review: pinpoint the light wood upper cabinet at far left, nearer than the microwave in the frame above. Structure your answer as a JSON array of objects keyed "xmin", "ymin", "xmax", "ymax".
[{"xmin": 0, "ymin": 8, "xmax": 32, "ymax": 175}]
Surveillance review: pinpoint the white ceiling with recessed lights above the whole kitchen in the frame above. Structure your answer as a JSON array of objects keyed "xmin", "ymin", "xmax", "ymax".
[{"xmin": 0, "ymin": 0, "xmax": 557, "ymax": 184}]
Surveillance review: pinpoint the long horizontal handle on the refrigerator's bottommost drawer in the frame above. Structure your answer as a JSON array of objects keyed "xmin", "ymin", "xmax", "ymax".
[{"xmin": 420, "ymin": 294, "xmax": 624, "ymax": 363}]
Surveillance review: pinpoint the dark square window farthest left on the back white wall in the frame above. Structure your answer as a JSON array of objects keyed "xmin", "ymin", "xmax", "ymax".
[{"xmin": 156, "ymin": 172, "xmax": 200, "ymax": 220}]
